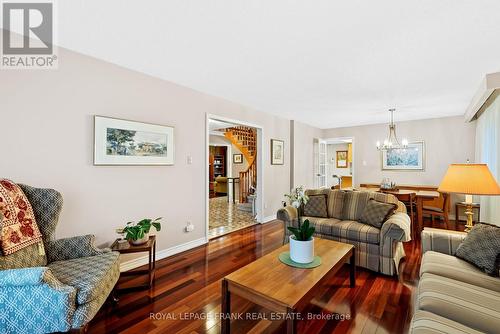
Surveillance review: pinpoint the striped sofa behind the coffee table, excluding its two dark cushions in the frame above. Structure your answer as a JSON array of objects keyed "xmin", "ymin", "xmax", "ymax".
[{"xmin": 277, "ymin": 189, "xmax": 411, "ymax": 276}]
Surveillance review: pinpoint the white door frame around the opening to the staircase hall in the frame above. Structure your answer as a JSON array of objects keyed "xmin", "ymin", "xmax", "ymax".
[{"xmin": 205, "ymin": 113, "xmax": 264, "ymax": 242}]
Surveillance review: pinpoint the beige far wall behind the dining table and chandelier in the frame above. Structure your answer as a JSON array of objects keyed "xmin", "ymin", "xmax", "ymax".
[{"xmin": 323, "ymin": 116, "xmax": 475, "ymax": 185}]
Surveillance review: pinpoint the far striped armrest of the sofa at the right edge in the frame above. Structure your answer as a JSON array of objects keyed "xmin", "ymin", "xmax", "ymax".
[{"xmin": 422, "ymin": 227, "xmax": 467, "ymax": 255}]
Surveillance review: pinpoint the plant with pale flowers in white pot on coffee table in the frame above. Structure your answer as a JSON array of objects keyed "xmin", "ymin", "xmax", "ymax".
[{"xmin": 285, "ymin": 187, "xmax": 315, "ymax": 263}]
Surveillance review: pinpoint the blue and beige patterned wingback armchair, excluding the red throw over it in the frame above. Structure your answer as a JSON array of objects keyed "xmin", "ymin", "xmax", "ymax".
[{"xmin": 0, "ymin": 185, "xmax": 120, "ymax": 333}]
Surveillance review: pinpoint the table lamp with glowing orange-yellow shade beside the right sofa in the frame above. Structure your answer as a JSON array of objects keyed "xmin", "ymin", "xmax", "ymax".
[{"xmin": 438, "ymin": 164, "xmax": 500, "ymax": 232}]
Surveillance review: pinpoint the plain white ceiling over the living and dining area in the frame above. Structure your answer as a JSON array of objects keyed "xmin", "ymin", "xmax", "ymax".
[{"xmin": 27, "ymin": 0, "xmax": 500, "ymax": 128}]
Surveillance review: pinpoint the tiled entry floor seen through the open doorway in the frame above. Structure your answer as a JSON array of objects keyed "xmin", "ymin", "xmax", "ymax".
[{"xmin": 208, "ymin": 196, "xmax": 257, "ymax": 239}]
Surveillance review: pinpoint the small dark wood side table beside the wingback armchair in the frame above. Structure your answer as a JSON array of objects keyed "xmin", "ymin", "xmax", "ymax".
[{"xmin": 111, "ymin": 235, "xmax": 156, "ymax": 291}]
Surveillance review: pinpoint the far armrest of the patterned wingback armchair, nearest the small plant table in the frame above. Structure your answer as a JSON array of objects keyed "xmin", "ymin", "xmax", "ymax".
[{"xmin": 46, "ymin": 234, "xmax": 111, "ymax": 263}]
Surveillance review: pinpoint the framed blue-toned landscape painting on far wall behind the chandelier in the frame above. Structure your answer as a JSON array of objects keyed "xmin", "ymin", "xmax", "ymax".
[{"xmin": 382, "ymin": 141, "xmax": 425, "ymax": 170}]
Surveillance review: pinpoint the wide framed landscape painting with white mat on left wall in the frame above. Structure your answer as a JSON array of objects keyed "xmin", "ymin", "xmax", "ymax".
[{"xmin": 94, "ymin": 116, "xmax": 174, "ymax": 165}]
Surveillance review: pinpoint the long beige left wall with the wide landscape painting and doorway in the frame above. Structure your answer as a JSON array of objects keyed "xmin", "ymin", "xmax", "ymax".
[{"xmin": 0, "ymin": 49, "xmax": 290, "ymax": 262}]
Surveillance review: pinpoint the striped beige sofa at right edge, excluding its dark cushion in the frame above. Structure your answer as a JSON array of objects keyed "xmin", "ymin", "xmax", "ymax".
[{"xmin": 410, "ymin": 228, "xmax": 500, "ymax": 334}]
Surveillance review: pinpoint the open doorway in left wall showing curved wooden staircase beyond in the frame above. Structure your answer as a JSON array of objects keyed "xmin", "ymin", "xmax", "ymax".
[{"xmin": 206, "ymin": 115, "xmax": 263, "ymax": 239}]
